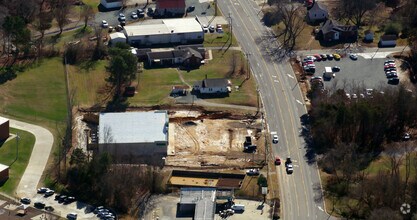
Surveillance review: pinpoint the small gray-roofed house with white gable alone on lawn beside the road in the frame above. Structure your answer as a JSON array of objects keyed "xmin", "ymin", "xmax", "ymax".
[{"xmin": 193, "ymin": 76, "xmax": 232, "ymax": 94}]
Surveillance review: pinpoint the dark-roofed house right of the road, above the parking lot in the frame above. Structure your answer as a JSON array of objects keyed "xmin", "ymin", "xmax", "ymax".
[{"xmin": 319, "ymin": 19, "xmax": 358, "ymax": 42}]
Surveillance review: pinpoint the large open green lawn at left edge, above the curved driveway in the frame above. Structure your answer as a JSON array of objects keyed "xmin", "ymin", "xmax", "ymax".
[{"xmin": 0, "ymin": 58, "xmax": 66, "ymax": 128}]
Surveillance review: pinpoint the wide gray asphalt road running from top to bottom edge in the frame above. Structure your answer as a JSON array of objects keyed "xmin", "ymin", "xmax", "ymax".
[{"xmin": 218, "ymin": 0, "xmax": 329, "ymax": 220}]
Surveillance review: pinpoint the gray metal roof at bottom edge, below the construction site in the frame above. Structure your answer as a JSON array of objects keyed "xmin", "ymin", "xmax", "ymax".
[{"xmin": 180, "ymin": 188, "xmax": 216, "ymax": 220}]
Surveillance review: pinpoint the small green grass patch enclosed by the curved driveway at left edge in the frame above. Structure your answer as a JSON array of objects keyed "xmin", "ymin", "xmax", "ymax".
[{"xmin": 0, "ymin": 128, "xmax": 35, "ymax": 196}]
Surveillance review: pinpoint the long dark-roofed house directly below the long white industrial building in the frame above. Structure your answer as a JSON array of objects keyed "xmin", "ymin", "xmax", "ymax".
[{"xmin": 146, "ymin": 47, "xmax": 205, "ymax": 68}]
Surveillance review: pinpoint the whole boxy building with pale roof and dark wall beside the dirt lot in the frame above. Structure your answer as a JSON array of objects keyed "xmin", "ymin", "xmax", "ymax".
[{"xmin": 98, "ymin": 111, "xmax": 169, "ymax": 163}]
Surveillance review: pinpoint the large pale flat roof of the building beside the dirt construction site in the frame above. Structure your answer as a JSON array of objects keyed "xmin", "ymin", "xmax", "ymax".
[{"xmin": 99, "ymin": 110, "xmax": 168, "ymax": 144}]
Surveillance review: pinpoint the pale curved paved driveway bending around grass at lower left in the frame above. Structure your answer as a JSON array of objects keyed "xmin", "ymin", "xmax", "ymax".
[{"xmin": 6, "ymin": 119, "xmax": 54, "ymax": 198}]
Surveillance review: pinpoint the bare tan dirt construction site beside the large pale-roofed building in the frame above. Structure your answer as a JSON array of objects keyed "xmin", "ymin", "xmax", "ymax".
[{"xmin": 165, "ymin": 111, "xmax": 265, "ymax": 168}]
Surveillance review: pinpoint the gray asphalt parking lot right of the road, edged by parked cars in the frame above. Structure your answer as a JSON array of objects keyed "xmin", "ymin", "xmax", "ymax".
[{"xmin": 308, "ymin": 54, "xmax": 402, "ymax": 93}]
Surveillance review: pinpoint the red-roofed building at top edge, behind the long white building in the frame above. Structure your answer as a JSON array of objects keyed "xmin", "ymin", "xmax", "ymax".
[{"xmin": 155, "ymin": 0, "xmax": 185, "ymax": 17}]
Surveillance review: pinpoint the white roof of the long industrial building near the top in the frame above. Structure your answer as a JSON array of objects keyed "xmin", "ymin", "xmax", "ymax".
[{"xmin": 123, "ymin": 18, "xmax": 203, "ymax": 37}]
